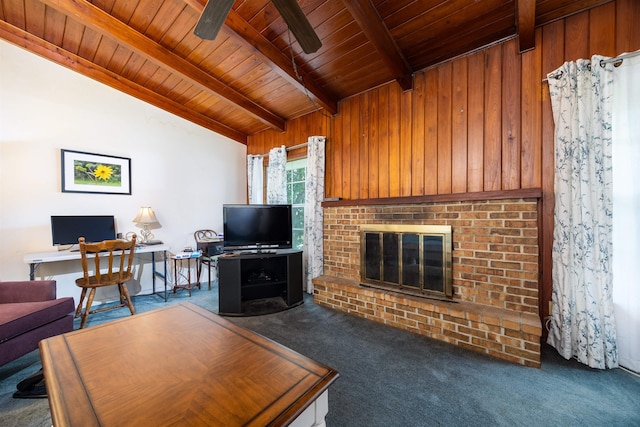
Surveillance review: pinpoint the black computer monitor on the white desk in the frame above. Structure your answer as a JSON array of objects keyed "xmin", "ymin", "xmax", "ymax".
[{"xmin": 51, "ymin": 215, "xmax": 116, "ymax": 246}]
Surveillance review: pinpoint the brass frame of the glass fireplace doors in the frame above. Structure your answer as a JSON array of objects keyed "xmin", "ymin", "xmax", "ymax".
[{"xmin": 360, "ymin": 224, "xmax": 453, "ymax": 299}]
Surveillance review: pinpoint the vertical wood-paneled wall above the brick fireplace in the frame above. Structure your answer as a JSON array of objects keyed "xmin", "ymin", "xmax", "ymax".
[{"xmin": 247, "ymin": 0, "xmax": 640, "ymax": 328}]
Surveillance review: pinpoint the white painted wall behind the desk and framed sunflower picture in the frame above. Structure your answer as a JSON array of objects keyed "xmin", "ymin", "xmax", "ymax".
[{"xmin": 0, "ymin": 40, "xmax": 246, "ymax": 302}]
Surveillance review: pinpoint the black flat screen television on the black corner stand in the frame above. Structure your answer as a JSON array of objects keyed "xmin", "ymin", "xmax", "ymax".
[{"xmin": 222, "ymin": 205, "xmax": 292, "ymax": 250}]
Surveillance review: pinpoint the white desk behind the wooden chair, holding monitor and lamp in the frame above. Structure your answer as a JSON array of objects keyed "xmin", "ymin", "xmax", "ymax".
[{"xmin": 23, "ymin": 245, "xmax": 169, "ymax": 301}]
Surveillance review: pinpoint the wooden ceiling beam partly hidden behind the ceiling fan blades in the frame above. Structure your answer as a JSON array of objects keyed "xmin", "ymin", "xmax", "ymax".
[{"xmin": 185, "ymin": 0, "xmax": 338, "ymax": 115}]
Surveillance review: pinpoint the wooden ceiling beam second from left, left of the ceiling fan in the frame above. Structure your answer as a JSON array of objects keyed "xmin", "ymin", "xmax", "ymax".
[{"xmin": 42, "ymin": 0, "xmax": 285, "ymax": 131}]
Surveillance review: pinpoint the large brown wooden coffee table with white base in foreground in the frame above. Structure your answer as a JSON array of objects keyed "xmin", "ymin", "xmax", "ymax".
[{"xmin": 40, "ymin": 303, "xmax": 338, "ymax": 427}]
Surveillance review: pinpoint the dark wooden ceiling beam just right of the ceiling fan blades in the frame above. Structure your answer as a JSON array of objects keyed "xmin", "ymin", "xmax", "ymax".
[{"xmin": 342, "ymin": 0, "xmax": 413, "ymax": 90}]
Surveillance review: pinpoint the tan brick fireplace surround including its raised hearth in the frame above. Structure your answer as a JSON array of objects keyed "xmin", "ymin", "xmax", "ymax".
[{"xmin": 313, "ymin": 195, "xmax": 542, "ymax": 367}]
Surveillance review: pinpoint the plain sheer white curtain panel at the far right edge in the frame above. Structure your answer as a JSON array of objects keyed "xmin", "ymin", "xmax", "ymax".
[{"xmin": 612, "ymin": 52, "xmax": 640, "ymax": 373}]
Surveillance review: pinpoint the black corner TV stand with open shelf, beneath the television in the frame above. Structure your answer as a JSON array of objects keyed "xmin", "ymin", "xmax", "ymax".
[{"xmin": 218, "ymin": 249, "xmax": 303, "ymax": 316}]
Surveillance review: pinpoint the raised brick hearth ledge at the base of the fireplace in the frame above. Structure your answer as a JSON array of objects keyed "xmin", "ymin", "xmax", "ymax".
[{"xmin": 313, "ymin": 275, "xmax": 542, "ymax": 368}]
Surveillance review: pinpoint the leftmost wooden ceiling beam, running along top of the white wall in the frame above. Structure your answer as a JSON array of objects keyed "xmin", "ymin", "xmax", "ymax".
[{"xmin": 0, "ymin": 20, "xmax": 247, "ymax": 145}]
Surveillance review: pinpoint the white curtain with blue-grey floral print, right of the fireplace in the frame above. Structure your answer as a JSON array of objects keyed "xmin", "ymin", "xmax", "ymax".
[{"xmin": 547, "ymin": 55, "xmax": 618, "ymax": 369}]
